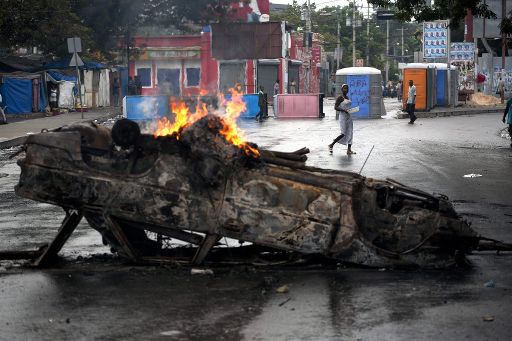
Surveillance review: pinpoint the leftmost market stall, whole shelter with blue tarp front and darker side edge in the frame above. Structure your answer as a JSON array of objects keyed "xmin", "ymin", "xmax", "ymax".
[{"xmin": 0, "ymin": 72, "xmax": 47, "ymax": 114}]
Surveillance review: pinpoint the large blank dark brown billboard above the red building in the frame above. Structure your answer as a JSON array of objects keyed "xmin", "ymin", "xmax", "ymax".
[{"xmin": 211, "ymin": 22, "xmax": 284, "ymax": 60}]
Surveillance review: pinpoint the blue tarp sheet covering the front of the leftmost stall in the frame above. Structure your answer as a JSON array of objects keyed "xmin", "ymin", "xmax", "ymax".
[{"xmin": 0, "ymin": 77, "xmax": 32, "ymax": 114}]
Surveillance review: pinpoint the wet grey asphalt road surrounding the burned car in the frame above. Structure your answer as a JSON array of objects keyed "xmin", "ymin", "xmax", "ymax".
[{"xmin": 0, "ymin": 97, "xmax": 512, "ymax": 340}]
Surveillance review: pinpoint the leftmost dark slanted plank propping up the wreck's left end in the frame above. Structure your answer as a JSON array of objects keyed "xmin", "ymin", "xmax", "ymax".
[{"xmin": 33, "ymin": 210, "xmax": 83, "ymax": 267}]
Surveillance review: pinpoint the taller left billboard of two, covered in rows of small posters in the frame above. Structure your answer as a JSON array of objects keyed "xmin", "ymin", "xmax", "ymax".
[{"xmin": 423, "ymin": 20, "xmax": 448, "ymax": 58}]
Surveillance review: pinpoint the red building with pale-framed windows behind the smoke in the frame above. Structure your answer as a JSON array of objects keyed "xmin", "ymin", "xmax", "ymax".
[{"xmin": 129, "ymin": 28, "xmax": 322, "ymax": 97}]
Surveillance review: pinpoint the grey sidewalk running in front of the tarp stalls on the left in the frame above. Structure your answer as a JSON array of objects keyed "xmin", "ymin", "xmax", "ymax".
[{"xmin": 0, "ymin": 107, "xmax": 121, "ymax": 149}]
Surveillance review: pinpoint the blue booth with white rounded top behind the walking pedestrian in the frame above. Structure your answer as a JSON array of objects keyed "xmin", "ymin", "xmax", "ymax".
[{"xmin": 336, "ymin": 66, "xmax": 386, "ymax": 118}]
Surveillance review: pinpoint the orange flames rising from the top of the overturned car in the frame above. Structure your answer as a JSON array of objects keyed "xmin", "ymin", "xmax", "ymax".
[{"xmin": 153, "ymin": 85, "xmax": 260, "ymax": 157}]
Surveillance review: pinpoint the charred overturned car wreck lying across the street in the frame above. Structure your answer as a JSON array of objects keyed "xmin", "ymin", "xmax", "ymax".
[{"xmin": 15, "ymin": 114, "xmax": 508, "ymax": 268}]
